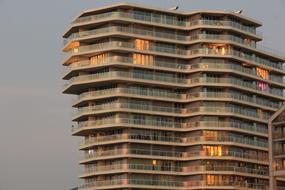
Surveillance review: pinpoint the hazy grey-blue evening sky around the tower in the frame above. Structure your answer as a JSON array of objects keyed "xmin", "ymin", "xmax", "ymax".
[{"xmin": 0, "ymin": 0, "xmax": 285, "ymax": 190}]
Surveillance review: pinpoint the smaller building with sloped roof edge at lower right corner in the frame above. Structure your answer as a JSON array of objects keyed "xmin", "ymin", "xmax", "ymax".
[{"xmin": 269, "ymin": 106, "xmax": 285, "ymax": 190}]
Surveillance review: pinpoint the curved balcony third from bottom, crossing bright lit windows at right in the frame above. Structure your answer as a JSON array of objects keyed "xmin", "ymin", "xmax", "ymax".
[{"xmin": 81, "ymin": 148, "xmax": 269, "ymax": 164}]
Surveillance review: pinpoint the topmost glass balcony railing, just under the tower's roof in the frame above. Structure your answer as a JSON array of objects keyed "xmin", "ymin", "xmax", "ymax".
[{"xmin": 72, "ymin": 12, "xmax": 261, "ymax": 36}]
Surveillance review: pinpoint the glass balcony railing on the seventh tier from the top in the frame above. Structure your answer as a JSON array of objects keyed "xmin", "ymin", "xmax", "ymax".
[{"xmin": 74, "ymin": 102, "xmax": 271, "ymax": 120}]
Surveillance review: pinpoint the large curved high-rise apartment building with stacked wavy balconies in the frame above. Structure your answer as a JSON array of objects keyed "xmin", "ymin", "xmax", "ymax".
[{"xmin": 63, "ymin": 3, "xmax": 285, "ymax": 190}]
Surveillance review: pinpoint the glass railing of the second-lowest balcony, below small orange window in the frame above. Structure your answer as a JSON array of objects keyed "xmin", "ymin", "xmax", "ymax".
[{"xmin": 81, "ymin": 163, "xmax": 268, "ymax": 175}]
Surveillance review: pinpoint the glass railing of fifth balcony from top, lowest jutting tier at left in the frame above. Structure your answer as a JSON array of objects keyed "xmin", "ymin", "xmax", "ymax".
[{"xmin": 65, "ymin": 71, "xmax": 283, "ymax": 97}]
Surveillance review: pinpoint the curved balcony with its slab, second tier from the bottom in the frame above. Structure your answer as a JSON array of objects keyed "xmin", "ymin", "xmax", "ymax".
[{"xmin": 81, "ymin": 163, "xmax": 269, "ymax": 178}]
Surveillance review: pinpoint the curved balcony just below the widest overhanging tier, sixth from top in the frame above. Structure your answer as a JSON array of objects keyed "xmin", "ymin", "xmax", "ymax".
[{"xmin": 73, "ymin": 88, "xmax": 280, "ymax": 111}]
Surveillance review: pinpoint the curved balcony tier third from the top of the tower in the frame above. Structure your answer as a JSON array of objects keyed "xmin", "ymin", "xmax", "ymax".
[{"xmin": 64, "ymin": 41, "xmax": 284, "ymax": 73}]
